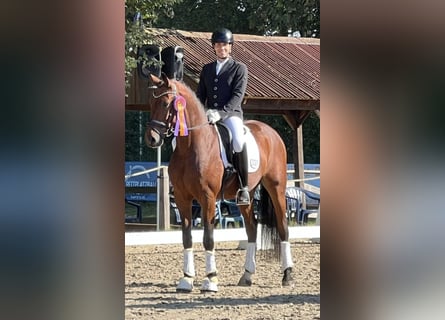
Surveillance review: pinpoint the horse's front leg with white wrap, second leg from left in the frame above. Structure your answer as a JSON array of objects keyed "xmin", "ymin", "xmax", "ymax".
[{"xmin": 201, "ymin": 206, "xmax": 218, "ymax": 292}]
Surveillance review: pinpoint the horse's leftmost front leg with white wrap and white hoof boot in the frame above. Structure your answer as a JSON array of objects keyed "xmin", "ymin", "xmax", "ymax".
[{"xmin": 176, "ymin": 207, "xmax": 196, "ymax": 292}]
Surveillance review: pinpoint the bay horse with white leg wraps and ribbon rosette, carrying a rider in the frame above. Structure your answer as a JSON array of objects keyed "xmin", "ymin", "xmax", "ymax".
[{"xmin": 144, "ymin": 74, "xmax": 293, "ymax": 292}]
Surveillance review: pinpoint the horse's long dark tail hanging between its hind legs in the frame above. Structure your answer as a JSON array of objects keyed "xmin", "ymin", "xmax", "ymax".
[{"xmin": 258, "ymin": 186, "xmax": 280, "ymax": 259}]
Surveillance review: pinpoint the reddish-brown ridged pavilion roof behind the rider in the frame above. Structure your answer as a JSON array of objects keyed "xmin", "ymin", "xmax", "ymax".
[{"xmin": 126, "ymin": 28, "xmax": 320, "ymax": 119}]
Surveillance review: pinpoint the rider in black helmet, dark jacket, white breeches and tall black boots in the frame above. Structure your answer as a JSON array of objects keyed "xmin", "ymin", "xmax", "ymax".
[{"xmin": 196, "ymin": 28, "xmax": 250, "ymax": 205}]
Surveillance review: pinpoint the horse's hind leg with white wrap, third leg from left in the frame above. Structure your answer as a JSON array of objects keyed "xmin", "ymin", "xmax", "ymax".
[{"xmin": 238, "ymin": 209, "xmax": 257, "ymax": 286}]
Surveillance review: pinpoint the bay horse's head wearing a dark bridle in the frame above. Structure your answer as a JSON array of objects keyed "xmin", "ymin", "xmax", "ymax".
[{"xmin": 144, "ymin": 74, "xmax": 177, "ymax": 148}]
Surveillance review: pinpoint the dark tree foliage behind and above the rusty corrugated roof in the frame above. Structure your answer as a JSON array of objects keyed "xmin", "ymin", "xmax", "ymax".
[{"xmin": 154, "ymin": 0, "xmax": 320, "ymax": 38}]
